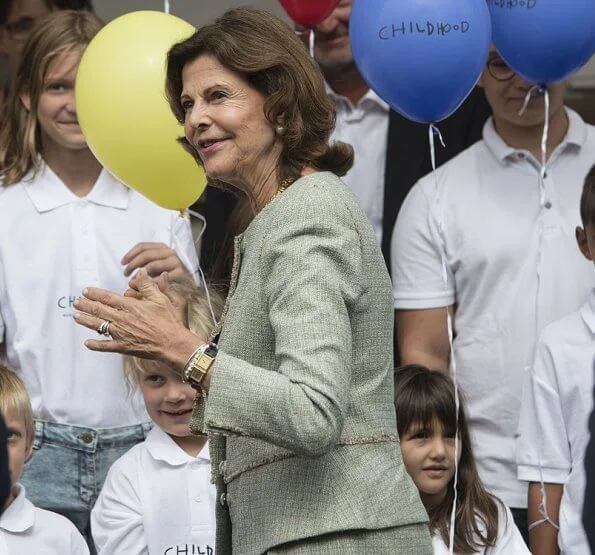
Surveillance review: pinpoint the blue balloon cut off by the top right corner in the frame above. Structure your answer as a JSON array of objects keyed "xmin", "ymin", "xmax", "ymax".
[{"xmin": 487, "ymin": 0, "xmax": 595, "ymax": 85}]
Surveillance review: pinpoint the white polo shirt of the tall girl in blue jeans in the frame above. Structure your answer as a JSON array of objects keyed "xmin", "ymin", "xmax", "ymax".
[{"xmin": 0, "ymin": 166, "xmax": 198, "ymax": 428}]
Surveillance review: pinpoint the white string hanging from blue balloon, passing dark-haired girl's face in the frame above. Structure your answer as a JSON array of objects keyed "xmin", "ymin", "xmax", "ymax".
[{"xmin": 428, "ymin": 123, "xmax": 460, "ymax": 555}]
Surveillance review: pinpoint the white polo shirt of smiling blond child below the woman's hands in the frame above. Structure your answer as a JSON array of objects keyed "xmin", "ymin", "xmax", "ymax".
[{"xmin": 91, "ymin": 426, "xmax": 217, "ymax": 555}]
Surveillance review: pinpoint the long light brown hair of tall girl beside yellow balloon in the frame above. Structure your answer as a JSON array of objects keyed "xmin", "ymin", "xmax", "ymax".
[{"xmin": 0, "ymin": 10, "xmax": 103, "ymax": 186}]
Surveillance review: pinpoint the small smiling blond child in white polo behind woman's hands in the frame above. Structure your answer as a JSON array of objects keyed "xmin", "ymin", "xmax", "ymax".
[{"xmin": 91, "ymin": 282, "xmax": 222, "ymax": 555}]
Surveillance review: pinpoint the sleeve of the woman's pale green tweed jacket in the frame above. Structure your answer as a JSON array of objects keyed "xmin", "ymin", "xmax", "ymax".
[{"xmin": 205, "ymin": 180, "xmax": 363, "ymax": 456}]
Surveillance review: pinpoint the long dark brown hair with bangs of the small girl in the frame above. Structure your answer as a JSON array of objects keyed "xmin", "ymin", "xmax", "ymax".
[{"xmin": 395, "ymin": 364, "xmax": 506, "ymax": 553}]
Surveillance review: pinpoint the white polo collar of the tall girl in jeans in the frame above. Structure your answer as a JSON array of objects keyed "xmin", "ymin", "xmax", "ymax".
[{"xmin": 24, "ymin": 164, "xmax": 130, "ymax": 212}]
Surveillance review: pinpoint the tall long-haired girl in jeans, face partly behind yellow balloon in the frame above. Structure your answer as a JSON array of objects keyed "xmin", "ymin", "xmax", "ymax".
[{"xmin": 0, "ymin": 10, "xmax": 197, "ymax": 540}]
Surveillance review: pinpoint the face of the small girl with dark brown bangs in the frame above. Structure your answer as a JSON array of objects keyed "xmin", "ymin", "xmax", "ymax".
[{"xmin": 401, "ymin": 422, "xmax": 460, "ymax": 507}]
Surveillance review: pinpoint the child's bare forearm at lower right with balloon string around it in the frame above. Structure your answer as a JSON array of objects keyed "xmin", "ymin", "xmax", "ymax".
[{"xmin": 529, "ymin": 482, "xmax": 564, "ymax": 555}]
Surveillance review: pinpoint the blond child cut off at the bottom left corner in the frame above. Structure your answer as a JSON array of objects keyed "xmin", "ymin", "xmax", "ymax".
[{"xmin": 0, "ymin": 364, "xmax": 89, "ymax": 555}]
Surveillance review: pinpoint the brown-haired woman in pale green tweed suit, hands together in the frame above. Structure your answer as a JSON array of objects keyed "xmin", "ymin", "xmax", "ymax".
[{"xmin": 76, "ymin": 8, "xmax": 431, "ymax": 555}]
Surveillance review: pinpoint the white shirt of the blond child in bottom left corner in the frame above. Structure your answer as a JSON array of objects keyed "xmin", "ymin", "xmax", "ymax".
[{"xmin": 0, "ymin": 484, "xmax": 89, "ymax": 555}]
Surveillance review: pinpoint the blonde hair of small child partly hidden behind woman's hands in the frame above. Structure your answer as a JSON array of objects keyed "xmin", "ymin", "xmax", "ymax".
[{"xmin": 124, "ymin": 279, "xmax": 223, "ymax": 391}]
